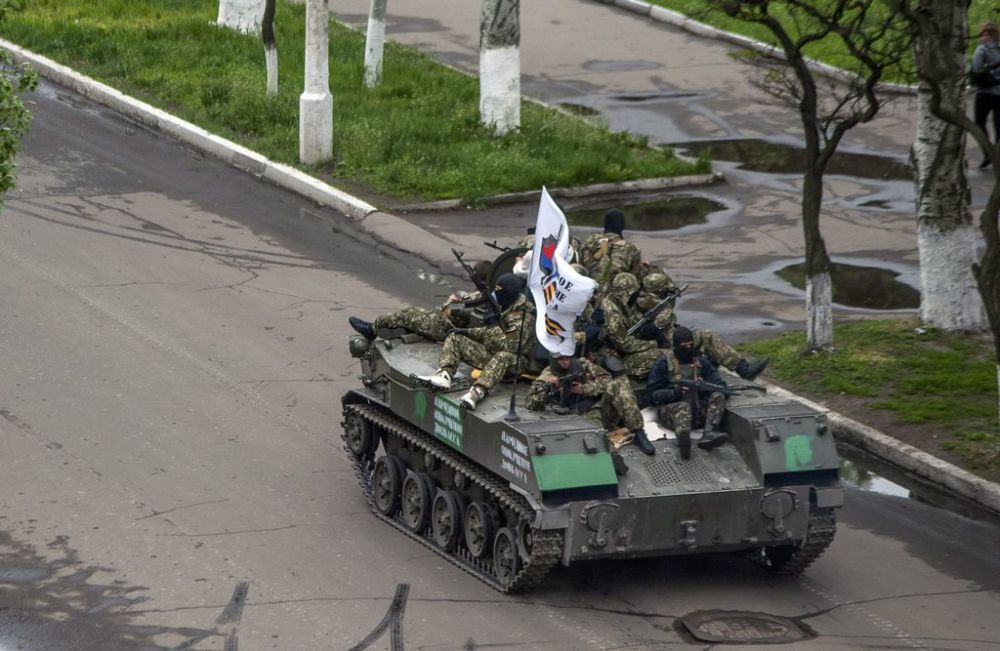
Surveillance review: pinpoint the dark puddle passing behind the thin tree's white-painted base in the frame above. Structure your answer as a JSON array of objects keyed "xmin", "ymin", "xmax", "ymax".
[{"xmin": 776, "ymin": 262, "xmax": 920, "ymax": 310}]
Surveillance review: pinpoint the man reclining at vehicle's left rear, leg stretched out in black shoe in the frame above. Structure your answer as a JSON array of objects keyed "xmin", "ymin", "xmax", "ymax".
[{"xmin": 348, "ymin": 261, "xmax": 490, "ymax": 342}]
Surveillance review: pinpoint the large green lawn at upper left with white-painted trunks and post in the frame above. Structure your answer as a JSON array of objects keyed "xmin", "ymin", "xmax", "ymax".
[{"xmin": 2, "ymin": 0, "xmax": 709, "ymax": 199}]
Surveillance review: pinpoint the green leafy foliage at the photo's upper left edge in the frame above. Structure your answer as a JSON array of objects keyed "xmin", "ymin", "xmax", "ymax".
[{"xmin": 0, "ymin": 0, "xmax": 38, "ymax": 205}]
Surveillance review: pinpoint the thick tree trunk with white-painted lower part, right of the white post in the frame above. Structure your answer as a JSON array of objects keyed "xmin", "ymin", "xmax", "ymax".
[{"xmin": 479, "ymin": 0, "xmax": 521, "ymax": 136}]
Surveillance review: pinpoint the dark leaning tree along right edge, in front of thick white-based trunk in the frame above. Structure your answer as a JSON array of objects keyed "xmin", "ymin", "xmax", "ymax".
[{"xmin": 892, "ymin": 0, "xmax": 1000, "ymax": 432}]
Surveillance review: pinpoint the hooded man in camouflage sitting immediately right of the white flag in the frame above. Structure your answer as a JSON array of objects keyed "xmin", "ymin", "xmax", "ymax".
[{"xmin": 600, "ymin": 273, "xmax": 661, "ymax": 380}]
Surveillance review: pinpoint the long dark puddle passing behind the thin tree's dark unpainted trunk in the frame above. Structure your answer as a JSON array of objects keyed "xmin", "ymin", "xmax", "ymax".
[{"xmin": 676, "ymin": 139, "xmax": 913, "ymax": 180}]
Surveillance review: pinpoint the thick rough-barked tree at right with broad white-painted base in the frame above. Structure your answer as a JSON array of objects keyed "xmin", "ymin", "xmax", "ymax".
[{"xmin": 912, "ymin": 0, "xmax": 986, "ymax": 330}]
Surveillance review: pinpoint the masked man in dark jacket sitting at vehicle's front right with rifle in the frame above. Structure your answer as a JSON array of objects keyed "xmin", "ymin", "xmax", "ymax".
[{"xmin": 646, "ymin": 326, "xmax": 729, "ymax": 459}]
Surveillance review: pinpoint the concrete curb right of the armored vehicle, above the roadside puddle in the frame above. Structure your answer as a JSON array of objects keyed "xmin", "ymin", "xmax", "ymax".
[{"xmin": 763, "ymin": 382, "xmax": 1000, "ymax": 516}]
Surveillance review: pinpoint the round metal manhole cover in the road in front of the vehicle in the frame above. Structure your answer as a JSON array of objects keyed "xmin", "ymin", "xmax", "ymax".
[{"xmin": 680, "ymin": 610, "xmax": 815, "ymax": 644}]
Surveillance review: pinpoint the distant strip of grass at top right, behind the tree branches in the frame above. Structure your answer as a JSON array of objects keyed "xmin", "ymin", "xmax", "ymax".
[{"xmin": 647, "ymin": 0, "xmax": 1000, "ymax": 83}]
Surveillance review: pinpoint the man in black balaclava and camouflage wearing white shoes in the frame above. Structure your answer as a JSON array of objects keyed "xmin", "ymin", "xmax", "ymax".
[{"xmin": 420, "ymin": 273, "xmax": 535, "ymax": 409}]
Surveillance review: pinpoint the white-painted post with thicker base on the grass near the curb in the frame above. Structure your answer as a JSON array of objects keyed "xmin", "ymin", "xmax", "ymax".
[{"xmin": 299, "ymin": 0, "xmax": 333, "ymax": 165}]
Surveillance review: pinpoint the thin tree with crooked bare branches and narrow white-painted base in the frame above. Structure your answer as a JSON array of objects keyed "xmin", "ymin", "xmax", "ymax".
[{"xmin": 709, "ymin": 0, "xmax": 907, "ymax": 350}]
